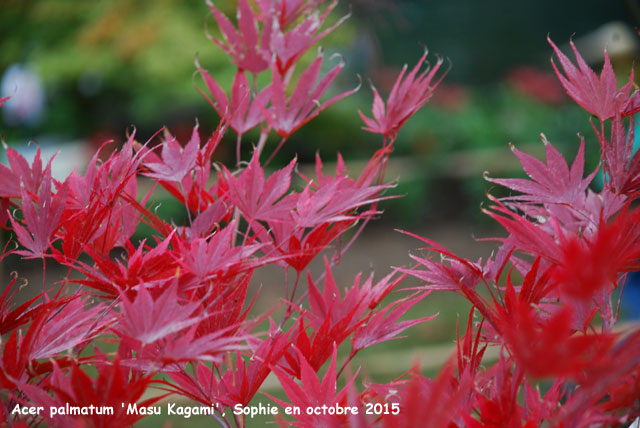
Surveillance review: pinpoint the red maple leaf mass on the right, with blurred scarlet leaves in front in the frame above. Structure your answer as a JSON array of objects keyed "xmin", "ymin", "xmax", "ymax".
[{"xmin": 398, "ymin": 40, "xmax": 640, "ymax": 427}]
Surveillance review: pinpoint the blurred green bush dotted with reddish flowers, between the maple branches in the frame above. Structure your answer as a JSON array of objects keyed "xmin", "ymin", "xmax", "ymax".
[{"xmin": 399, "ymin": 83, "xmax": 590, "ymax": 153}]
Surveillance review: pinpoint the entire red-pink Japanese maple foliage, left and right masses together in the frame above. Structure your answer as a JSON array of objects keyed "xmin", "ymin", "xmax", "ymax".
[{"xmin": 0, "ymin": 0, "xmax": 640, "ymax": 427}]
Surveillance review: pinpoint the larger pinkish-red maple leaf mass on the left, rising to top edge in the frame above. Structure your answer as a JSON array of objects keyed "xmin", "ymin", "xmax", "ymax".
[{"xmin": 0, "ymin": 0, "xmax": 439, "ymax": 427}]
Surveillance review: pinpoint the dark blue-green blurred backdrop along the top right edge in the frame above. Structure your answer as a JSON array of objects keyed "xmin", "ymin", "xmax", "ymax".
[{"xmin": 360, "ymin": 0, "xmax": 640, "ymax": 85}]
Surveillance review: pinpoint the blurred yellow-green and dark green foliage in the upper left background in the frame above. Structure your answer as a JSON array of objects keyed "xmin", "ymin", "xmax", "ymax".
[{"xmin": 0, "ymin": 0, "xmax": 353, "ymax": 142}]
